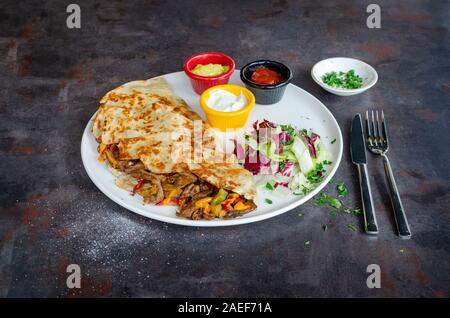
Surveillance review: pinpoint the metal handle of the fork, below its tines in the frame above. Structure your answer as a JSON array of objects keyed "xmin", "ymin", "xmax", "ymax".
[{"xmin": 383, "ymin": 155, "xmax": 411, "ymax": 239}]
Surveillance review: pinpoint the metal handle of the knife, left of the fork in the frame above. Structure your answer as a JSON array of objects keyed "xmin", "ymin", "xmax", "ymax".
[{"xmin": 357, "ymin": 164, "xmax": 378, "ymax": 235}]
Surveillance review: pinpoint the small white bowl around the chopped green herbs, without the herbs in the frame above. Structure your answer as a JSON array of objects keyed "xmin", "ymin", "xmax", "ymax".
[{"xmin": 311, "ymin": 57, "xmax": 378, "ymax": 96}]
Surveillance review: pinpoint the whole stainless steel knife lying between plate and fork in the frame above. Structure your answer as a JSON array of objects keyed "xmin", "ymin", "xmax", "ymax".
[{"xmin": 350, "ymin": 114, "xmax": 378, "ymax": 235}]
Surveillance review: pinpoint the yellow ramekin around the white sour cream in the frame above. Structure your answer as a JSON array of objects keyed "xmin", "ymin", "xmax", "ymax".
[{"xmin": 200, "ymin": 84, "xmax": 255, "ymax": 131}]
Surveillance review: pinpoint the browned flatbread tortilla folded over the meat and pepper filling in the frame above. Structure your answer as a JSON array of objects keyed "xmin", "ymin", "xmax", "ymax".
[{"xmin": 92, "ymin": 77, "xmax": 256, "ymax": 200}]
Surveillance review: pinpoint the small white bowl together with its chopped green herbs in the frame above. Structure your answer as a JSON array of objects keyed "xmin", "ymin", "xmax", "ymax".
[{"xmin": 311, "ymin": 57, "xmax": 378, "ymax": 96}]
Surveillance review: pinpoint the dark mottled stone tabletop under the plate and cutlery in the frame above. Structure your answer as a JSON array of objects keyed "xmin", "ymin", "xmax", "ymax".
[{"xmin": 0, "ymin": 0, "xmax": 450, "ymax": 297}]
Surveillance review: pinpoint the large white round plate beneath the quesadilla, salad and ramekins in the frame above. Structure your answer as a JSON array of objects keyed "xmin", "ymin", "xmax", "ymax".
[{"xmin": 81, "ymin": 71, "xmax": 342, "ymax": 226}]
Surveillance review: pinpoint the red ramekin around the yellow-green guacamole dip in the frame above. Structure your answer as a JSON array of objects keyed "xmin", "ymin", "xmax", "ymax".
[{"xmin": 183, "ymin": 52, "xmax": 236, "ymax": 94}]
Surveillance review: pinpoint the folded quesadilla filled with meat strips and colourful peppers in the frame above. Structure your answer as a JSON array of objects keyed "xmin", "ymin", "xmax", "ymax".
[{"xmin": 92, "ymin": 77, "xmax": 256, "ymax": 219}]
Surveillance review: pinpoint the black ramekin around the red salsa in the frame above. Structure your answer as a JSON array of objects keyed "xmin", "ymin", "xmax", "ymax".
[{"xmin": 241, "ymin": 60, "xmax": 292, "ymax": 105}]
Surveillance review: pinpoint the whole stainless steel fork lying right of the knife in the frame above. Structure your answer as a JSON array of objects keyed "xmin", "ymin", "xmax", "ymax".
[{"xmin": 366, "ymin": 110, "xmax": 411, "ymax": 238}]
